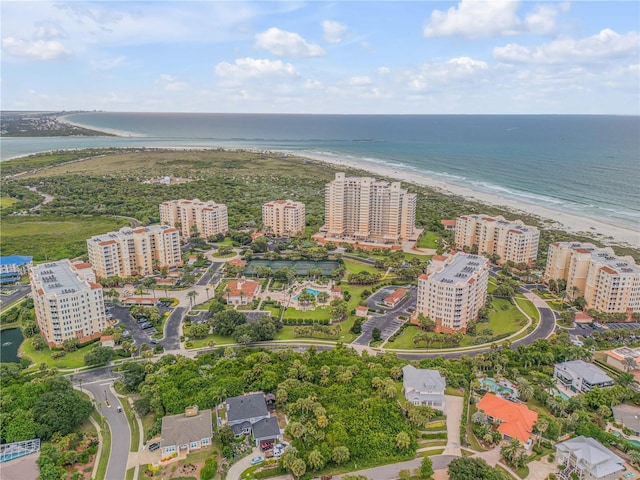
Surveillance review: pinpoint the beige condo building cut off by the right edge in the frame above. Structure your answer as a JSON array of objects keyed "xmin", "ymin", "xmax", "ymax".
[{"xmin": 545, "ymin": 242, "xmax": 640, "ymax": 313}]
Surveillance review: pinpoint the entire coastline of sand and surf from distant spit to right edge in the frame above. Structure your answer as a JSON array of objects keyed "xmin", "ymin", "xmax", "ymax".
[{"xmin": 6, "ymin": 112, "xmax": 640, "ymax": 247}]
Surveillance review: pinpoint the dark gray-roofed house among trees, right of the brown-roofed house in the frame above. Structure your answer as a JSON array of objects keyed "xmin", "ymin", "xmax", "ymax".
[{"xmin": 227, "ymin": 392, "xmax": 282, "ymax": 446}]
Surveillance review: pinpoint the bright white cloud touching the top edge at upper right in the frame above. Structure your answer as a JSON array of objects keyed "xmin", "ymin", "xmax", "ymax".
[{"xmin": 424, "ymin": 0, "xmax": 568, "ymax": 38}]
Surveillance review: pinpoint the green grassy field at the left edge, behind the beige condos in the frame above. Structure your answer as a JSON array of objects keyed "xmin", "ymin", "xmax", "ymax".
[{"xmin": 2, "ymin": 217, "xmax": 128, "ymax": 262}]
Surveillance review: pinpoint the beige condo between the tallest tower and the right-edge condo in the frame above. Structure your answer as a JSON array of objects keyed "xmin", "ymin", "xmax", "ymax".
[{"xmin": 455, "ymin": 215, "xmax": 540, "ymax": 265}]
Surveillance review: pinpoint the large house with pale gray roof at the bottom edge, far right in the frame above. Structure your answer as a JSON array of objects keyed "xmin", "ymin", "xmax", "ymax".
[{"xmin": 555, "ymin": 435, "xmax": 625, "ymax": 480}]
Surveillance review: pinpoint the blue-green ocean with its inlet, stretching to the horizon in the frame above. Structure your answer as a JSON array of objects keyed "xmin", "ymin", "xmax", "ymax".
[{"xmin": 1, "ymin": 112, "xmax": 640, "ymax": 231}]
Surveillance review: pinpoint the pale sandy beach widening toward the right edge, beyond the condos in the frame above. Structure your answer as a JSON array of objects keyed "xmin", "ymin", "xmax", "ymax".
[{"xmin": 301, "ymin": 153, "xmax": 640, "ymax": 247}]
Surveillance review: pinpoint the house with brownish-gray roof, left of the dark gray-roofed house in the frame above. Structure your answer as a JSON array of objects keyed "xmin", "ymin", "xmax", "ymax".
[{"xmin": 160, "ymin": 407, "xmax": 213, "ymax": 456}]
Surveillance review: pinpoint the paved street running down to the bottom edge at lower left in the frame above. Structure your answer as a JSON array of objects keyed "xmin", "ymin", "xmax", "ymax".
[{"xmin": 73, "ymin": 367, "xmax": 131, "ymax": 480}]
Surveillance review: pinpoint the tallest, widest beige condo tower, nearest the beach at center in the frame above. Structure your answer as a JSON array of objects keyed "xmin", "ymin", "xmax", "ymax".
[{"xmin": 321, "ymin": 173, "xmax": 416, "ymax": 243}]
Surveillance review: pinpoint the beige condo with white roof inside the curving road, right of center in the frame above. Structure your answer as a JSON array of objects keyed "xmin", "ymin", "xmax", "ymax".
[{"xmin": 413, "ymin": 252, "xmax": 490, "ymax": 333}]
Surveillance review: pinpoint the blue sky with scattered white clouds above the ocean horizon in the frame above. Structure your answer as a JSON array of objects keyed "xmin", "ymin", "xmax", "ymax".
[{"xmin": 0, "ymin": 0, "xmax": 640, "ymax": 115}]
